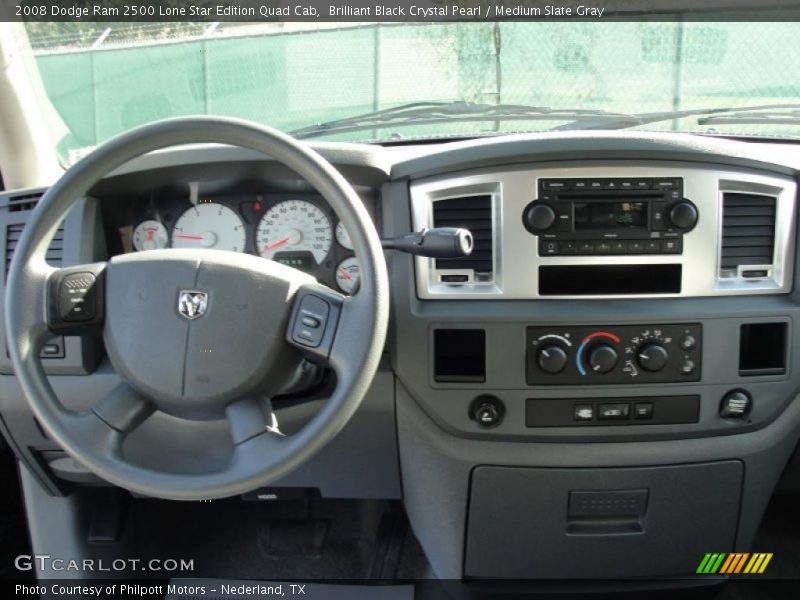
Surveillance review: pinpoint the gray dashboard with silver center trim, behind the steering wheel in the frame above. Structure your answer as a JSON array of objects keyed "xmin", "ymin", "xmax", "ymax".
[{"xmin": 0, "ymin": 132, "xmax": 800, "ymax": 579}]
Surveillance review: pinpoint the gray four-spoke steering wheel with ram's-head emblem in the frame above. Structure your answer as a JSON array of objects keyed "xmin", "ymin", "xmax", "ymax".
[{"xmin": 5, "ymin": 117, "xmax": 389, "ymax": 500}]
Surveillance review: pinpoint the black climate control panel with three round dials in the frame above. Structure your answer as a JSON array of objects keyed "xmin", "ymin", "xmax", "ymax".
[{"xmin": 525, "ymin": 323, "xmax": 702, "ymax": 385}]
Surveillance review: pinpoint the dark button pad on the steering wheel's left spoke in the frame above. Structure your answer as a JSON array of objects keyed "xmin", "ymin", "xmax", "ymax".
[{"xmin": 45, "ymin": 262, "xmax": 106, "ymax": 335}]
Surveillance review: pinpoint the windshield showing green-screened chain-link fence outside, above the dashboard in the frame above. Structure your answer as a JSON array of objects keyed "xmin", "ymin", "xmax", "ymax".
[{"xmin": 18, "ymin": 20, "xmax": 800, "ymax": 163}]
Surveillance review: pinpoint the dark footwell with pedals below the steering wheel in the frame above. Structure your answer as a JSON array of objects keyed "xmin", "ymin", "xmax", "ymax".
[{"xmin": 126, "ymin": 498, "xmax": 431, "ymax": 581}]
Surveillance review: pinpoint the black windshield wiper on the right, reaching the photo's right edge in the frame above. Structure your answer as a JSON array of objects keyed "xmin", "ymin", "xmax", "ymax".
[{"xmin": 553, "ymin": 104, "xmax": 800, "ymax": 131}]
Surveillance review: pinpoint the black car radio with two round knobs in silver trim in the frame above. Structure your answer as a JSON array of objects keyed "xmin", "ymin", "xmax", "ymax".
[{"xmin": 522, "ymin": 177, "xmax": 699, "ymax": 256}]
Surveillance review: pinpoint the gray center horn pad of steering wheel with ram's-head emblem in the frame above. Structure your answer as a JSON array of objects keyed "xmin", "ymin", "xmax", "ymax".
[{"xmin": 103, "ymin": 249, "xmax": 315, "ymax": 418}]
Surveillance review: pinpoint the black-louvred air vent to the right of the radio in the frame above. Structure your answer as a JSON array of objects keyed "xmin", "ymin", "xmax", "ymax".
[{"xmin": 720, "ymin": 193, "xmax": 777, "ymax": 273}]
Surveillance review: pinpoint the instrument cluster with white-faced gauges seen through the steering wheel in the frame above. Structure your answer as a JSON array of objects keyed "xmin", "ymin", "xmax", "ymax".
[{"xmin": 112, "ymin": 193, "xmax": 360, "ymax": 294}]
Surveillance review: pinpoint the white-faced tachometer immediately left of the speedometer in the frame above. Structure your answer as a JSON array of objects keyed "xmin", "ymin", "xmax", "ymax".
[{"xmin": 172, "ymin": 202, "xmax": 245, "ymax": 252}]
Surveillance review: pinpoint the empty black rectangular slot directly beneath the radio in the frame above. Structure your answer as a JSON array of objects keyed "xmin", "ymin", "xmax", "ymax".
[{"xmin": 539, "ymin": 264, "xmax": 681, "ymax": 296}]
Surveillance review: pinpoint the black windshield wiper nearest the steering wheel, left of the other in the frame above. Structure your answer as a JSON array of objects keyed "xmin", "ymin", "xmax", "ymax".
[{"xmin": 289, "ymin": 102, "xmax": 636, "ymax": 139}]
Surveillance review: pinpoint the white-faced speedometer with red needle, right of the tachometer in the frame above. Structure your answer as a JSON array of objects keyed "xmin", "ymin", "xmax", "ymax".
[{"xmin": 256, "ymin": 200, "xmax": 333, "ymax": 264}]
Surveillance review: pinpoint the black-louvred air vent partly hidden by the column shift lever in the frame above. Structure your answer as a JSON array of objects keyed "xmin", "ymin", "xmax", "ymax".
[{"xmin": 433, "ymin": 196, "xmax": 493, "ymax": 281}]
